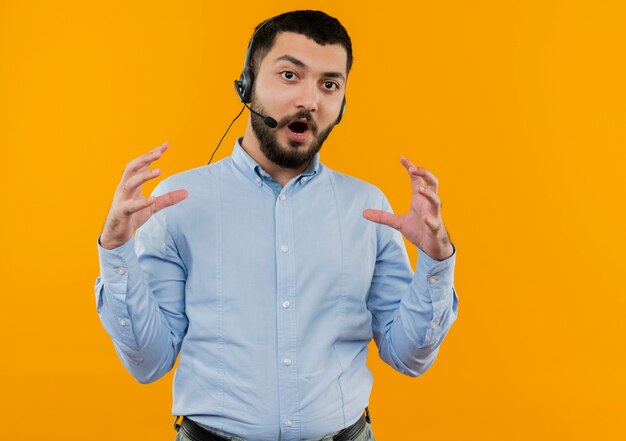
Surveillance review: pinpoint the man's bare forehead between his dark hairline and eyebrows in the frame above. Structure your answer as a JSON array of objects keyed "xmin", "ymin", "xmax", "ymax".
[{"xmin": 261, "ymin": 32, "xmax": 348, "ymax": 77}]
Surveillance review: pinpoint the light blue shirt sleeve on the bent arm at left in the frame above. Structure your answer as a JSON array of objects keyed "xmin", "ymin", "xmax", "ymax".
[{"xmin": 95, "ymin": 200, "xmax": 188, "ymax": 383}]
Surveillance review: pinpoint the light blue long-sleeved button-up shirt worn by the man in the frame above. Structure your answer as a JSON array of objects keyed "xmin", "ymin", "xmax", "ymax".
[{"xmin": 95, "ymin": 142, "xmax": 458, "ymax": 441}]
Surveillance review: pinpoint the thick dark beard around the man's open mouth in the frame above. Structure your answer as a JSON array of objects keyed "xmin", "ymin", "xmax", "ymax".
[{"xmin": 251, "ymin": 92, "xmax": 334, "ymax": 168}]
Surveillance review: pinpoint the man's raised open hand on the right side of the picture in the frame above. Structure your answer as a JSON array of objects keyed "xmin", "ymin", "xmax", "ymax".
[{"xmin": 363, "ymin": 157, "xmax": 454, "ymax": 260}]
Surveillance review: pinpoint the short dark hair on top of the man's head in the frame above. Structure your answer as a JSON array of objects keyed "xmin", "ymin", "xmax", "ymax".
[{"xmin": 250, "ymin": 10, "xmax": 352, "ymax": 74}]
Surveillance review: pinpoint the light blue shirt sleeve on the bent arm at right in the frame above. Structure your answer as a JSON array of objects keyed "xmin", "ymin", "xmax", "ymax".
[{"xmin": 368, "ymin": 194, "xmax": 458, "ymax": 376}]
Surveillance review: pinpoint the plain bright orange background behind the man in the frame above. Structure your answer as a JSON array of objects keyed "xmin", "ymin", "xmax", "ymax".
[{"xmin": 0, "ymin": 0, "xmax": 626, "ymax": 441}]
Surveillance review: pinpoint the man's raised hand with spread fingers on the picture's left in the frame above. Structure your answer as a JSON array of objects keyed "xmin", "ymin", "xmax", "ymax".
[{"xmin": 100, "ymin": 142, "xmax": 188, "ymax": 250}]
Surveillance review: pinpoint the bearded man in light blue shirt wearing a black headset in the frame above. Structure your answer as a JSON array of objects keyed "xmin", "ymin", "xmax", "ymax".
[{"xmin": 95, "ymin": 11, "xmax": 458, "ymax": 441}]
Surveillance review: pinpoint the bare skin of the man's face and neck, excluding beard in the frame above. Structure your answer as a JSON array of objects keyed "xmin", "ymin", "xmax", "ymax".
[{"xmin": 242, "ymin": 32, "xmax": 348, "ymax": 186}]
